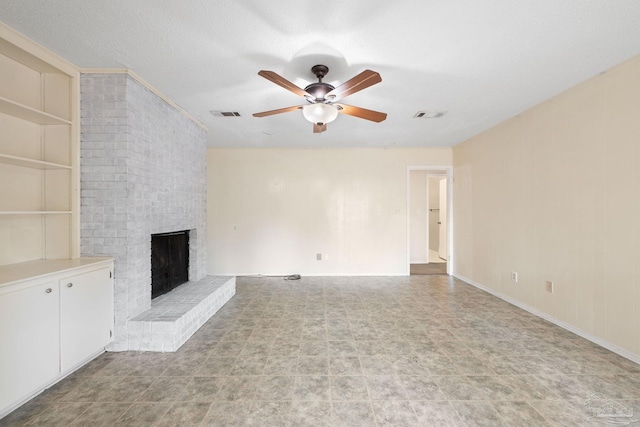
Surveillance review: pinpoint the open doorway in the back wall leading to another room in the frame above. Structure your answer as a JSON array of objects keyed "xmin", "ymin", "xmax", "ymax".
[{"xmin": 407, "ymin": 167, "xmax": 451, "ymax": 275}]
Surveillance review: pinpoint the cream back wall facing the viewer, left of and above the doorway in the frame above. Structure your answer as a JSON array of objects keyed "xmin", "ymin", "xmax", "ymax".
[{"xmin": 207, "ymin": 148, "xmax": 452, "ymax": 275}]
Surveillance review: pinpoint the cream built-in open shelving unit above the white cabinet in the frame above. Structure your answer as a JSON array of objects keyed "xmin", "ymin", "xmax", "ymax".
[{"xmin": 0, "ymin": 23, "xmax": 80, "ymax": 268}]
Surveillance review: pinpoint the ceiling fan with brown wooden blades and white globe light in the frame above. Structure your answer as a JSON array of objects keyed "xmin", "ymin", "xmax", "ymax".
[{"xmin": 253, "ymin": 65, "xmax": 387, "ymax": 133}]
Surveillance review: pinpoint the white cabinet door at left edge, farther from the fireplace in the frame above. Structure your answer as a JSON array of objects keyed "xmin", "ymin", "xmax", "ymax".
[{"xmin": 0, "ymin": 282, "xmax": 60, "ymax": 408}]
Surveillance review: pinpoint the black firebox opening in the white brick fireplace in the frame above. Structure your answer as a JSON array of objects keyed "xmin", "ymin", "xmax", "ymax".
[{"xmin": 151, "ymin": 230, "xmax": 189, "ymax": 299}]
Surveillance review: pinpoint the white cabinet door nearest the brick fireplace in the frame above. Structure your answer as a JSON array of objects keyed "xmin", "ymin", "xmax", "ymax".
[{"xmin": 60, "ymin": 268, "xmax": 113, "ymax": 372}]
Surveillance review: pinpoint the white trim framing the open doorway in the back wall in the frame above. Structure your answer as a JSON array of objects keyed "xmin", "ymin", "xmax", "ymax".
[{"xmin": 406, "ymin": 165, "xmax": 453, "ymax": 276}]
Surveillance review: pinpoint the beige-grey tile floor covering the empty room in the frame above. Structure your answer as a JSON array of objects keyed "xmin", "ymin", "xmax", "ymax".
[{"xmin": 0, "ymin": 276, "xmax": 640, "ymax": 427}]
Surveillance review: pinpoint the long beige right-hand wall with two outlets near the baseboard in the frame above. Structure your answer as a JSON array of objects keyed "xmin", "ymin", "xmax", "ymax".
[{"xmin": 453, "ymin": 53, "xmax": 640, "ymax": 360}]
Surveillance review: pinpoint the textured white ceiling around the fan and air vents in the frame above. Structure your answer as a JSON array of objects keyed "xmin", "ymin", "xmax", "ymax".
[{"xmin": 0, "ymin": 0, "xmax": 640, "ymax": 147}]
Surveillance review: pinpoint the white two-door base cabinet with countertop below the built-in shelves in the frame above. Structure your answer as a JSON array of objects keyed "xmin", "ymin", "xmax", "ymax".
[{"xmin": 0, "ymin": 258, "xmax": 114, "ymax": 418}]
